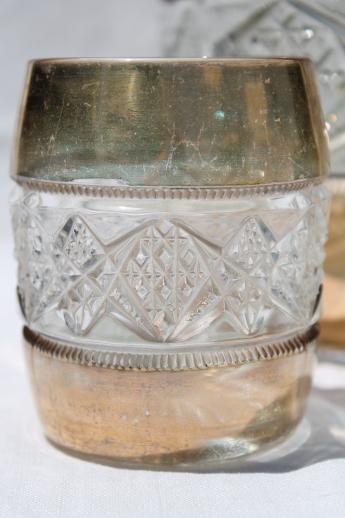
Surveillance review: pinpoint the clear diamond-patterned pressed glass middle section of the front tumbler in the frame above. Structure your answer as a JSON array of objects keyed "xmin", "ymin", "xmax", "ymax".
[{"xmin": 13, "ymin": 186, "xmax": 328, "ymax": 345}]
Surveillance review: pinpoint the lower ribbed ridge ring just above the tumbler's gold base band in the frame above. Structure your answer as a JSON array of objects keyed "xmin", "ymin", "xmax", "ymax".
[{"xmin": 23, "ymin": 325, "xmax": 319, "ymax": 371}]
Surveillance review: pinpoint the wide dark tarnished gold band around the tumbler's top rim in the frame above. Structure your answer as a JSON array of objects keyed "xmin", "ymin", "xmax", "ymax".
[{"xmin": 12, "ymin": 58, "xmax": 328, "ymax": 187}]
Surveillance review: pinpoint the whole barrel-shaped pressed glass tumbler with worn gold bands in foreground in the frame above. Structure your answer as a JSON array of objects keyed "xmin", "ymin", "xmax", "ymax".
[{"xmin": 12, "ymin": 58, "xmax": 328, "ymax": 466}]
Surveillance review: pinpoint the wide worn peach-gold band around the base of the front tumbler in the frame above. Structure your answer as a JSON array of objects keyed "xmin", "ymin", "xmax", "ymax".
[{"xmin": 24, "ymin": 324, "xmax": 313, "ymax": 465}]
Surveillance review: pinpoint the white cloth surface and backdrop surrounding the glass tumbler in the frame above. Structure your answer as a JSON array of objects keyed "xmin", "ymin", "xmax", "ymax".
[{"xmin": 0, "ymin": 0, "xmax": 345, "ymax": 518}]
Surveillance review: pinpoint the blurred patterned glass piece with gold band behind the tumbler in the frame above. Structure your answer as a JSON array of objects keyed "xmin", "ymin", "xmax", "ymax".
[{"xmin": 164, "ymin": 0, "xmax": 345, "ymax": 346}]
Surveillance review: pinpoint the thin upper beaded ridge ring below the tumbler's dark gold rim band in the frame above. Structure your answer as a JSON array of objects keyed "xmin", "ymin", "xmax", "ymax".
[{"xmin": 14, "ymin": 176, "xmax": 326, "ymax": 200}]
